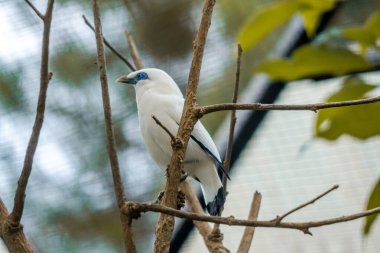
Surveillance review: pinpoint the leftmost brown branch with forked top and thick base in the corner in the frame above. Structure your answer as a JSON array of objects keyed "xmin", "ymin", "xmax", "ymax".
[{"xmin": 0, "ymin": 0, "xmax": 54, "ymax": 253}]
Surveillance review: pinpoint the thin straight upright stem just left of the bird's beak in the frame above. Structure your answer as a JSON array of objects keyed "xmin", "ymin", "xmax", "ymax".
[{"xmin": 93, "ymin": 0, "xmax": 136, "ymax": 253}]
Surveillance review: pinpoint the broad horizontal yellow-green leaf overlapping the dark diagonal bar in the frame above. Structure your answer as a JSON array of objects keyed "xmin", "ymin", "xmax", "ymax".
[{"xmin": 255, "ymin": 45, "xmax": 370, "ymax": 81}]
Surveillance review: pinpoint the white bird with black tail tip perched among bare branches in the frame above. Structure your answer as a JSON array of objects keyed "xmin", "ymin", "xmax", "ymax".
[{"xmin": 116, "ymin": 68, "xmax": 226, "ymax": 215}]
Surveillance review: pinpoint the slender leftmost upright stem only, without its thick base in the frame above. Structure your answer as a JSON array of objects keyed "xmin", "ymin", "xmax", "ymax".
[{"xmin": 10, "ymin": 0, "xmax": 54, "ymax": 227}]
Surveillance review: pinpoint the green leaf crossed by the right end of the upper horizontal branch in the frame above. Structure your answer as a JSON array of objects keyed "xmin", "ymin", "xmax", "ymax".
[{"xmin": 315, "ymin": 77, "xmax": 380, "ymax": 140}]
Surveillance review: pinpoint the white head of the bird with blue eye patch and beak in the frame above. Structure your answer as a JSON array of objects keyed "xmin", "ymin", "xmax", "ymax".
[{"xmin": 116, "ymin": 68, "xmax": 182, "ymax": 96}]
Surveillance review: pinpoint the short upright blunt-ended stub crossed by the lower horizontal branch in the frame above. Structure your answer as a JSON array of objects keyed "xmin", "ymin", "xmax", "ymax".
[{"xmin": 237, "ymin": 191, "xmax": 261, "ymax": 253}]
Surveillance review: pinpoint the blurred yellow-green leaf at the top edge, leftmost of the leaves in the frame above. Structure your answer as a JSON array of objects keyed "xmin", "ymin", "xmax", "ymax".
[{"xmin": 237, "ymin": 1, "xmax": 300, "ymax": 51}]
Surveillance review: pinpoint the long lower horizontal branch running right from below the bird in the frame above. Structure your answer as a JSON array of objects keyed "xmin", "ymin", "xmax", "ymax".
[{"xmin": 123, "ymin": 202, "xmax": 380, "ymax": 235}]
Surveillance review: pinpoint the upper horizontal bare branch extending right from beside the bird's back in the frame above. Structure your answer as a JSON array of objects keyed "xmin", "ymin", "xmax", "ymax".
[{"xmin": 198, "ymin": 96, "xmax": 380, "ymax": 118}]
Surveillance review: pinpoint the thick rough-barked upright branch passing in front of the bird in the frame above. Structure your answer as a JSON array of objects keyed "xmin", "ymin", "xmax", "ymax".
[{"xmin": 154, "ymin": 0, "xmax": 215, "ymax": 253}]
